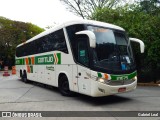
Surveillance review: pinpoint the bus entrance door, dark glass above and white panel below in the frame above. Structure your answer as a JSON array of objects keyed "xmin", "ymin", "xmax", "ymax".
[{"xmin": 77, "ymin": 36, "xmax": 91, "ymax": 95}]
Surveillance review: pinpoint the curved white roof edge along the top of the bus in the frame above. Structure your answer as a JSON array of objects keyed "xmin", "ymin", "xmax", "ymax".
[{"xmin": 17, "ymin": 19, "xmax": 125, "ymax": 47}]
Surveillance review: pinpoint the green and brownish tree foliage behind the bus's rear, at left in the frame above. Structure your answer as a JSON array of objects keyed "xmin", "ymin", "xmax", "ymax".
[{"xmin": 0, "ymin": 17, "xmax": 44, "ymax": 68}]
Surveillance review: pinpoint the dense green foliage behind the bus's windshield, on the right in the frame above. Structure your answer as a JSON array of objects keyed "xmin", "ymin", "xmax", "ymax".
[{"xmin": 92, "ymin": 4, "xmax": 160, "ymax": 82}]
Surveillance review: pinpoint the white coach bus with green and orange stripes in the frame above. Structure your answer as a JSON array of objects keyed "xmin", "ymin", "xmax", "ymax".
[{"xmin": 15, "ymin": 20, "xmax": 145, "ymax": 97}]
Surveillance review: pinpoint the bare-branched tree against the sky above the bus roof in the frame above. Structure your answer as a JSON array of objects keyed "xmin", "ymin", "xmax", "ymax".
[{"xmin": 60, "ymin": 0, "xmax": 122, "ymax": 19}]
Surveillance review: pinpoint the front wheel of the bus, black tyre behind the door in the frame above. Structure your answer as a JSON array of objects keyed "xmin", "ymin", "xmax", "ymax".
[{"xmin": 58, "ymin": 75, "xmax": 72, "ymax": 96}]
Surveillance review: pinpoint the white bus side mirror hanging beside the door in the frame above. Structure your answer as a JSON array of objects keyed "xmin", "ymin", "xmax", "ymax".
[{"xmin": 75, "ymin": 30, "xmax": 96, "ymax": 48}]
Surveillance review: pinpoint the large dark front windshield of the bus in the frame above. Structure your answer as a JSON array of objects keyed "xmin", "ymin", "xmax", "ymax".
[{"xmin": 87, "ymin": 25, "xmax": 135, "ymax": 72}]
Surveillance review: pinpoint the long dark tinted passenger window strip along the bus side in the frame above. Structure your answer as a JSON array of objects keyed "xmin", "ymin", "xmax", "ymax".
[{"xmin": 16, "ymin": 29, "xmax": 68, "ymax": 57}]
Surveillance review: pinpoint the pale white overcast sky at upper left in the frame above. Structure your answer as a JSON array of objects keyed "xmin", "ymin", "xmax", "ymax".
[{"xmin": 0, "ymin": 0, "xmax": 81, "ymax": 28}]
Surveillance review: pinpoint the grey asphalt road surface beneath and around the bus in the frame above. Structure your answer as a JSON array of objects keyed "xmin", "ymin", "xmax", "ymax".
[{"xmin": 0, "ymin": 71, "xmax": 160, "ymax": 120}]
